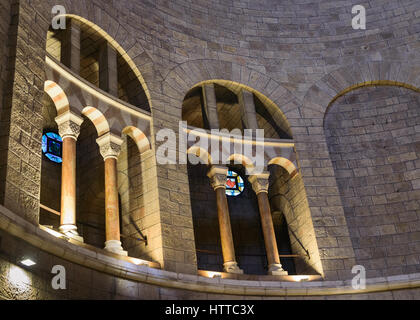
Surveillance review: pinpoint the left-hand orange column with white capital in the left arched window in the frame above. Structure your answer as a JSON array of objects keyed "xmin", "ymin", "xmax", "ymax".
[{"xmin": 55, "ymin": 111, "xmax": 83, "ymax": 241}]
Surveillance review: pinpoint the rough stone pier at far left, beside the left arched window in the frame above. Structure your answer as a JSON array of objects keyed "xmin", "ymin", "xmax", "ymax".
[{"xmin": 1, "ymin": 2, "xmax": 48, "ymax": 224}]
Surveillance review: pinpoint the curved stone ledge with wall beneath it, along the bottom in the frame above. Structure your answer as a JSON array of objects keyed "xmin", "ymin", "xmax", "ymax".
[{"xmin": 0, "ymin": 207, "xmax": 420, "ymax": 300}]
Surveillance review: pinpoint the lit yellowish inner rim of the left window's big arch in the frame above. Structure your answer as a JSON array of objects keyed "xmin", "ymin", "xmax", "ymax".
[{"xmin": 49, "ymin": 14, "xmax": 153, "ymax": 110}]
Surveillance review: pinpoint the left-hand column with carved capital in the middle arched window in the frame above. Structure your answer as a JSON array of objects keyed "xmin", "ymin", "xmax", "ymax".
[{"xmin": 207, "ymin": 166, "xmax": 243, "ymax": 274}]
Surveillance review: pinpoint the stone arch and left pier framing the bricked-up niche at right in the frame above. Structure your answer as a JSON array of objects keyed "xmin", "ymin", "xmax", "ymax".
[{"xmin": 294, "ymin": 62, "xmax": 420, "ymax": 279}]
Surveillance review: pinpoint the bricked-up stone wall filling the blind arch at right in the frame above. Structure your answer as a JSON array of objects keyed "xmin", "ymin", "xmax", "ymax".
[{"xmin": 325, "ymin": 87, "xmax": 420, "ymax": 277}]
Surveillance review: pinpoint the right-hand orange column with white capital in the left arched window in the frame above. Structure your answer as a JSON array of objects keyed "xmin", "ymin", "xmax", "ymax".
[{"xmin": 96, "ymin": 133, "xmax": 127, "ymax": 256}]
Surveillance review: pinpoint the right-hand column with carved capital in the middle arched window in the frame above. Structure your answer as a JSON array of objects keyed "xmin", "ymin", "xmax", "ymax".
[{"xmin": 248, "ymin": 172, "xmax": 287, "ymax": 276}]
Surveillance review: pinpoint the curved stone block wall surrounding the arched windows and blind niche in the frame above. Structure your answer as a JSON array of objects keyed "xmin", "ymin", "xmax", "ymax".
[{"xmin": 0, "ymin": 0, "xmax": 420, "ymax": 298}]
